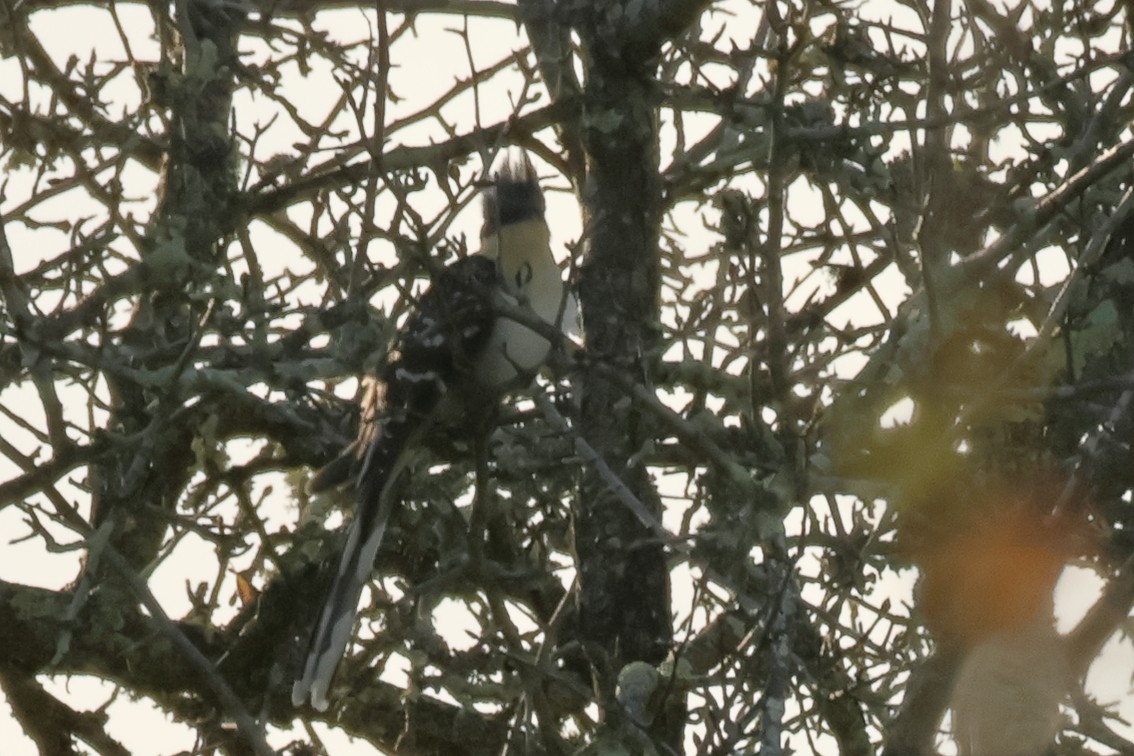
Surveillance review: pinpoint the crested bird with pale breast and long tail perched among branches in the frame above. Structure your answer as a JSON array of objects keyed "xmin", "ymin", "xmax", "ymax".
[{"xmin": 291, "ymin": 150, "xmax": 565, "ymax": 711}]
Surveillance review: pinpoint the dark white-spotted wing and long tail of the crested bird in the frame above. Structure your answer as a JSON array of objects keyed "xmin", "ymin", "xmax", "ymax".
[{"xmin": 291, "ymin": 256, "xmax": 499, "ymax": 711}]
